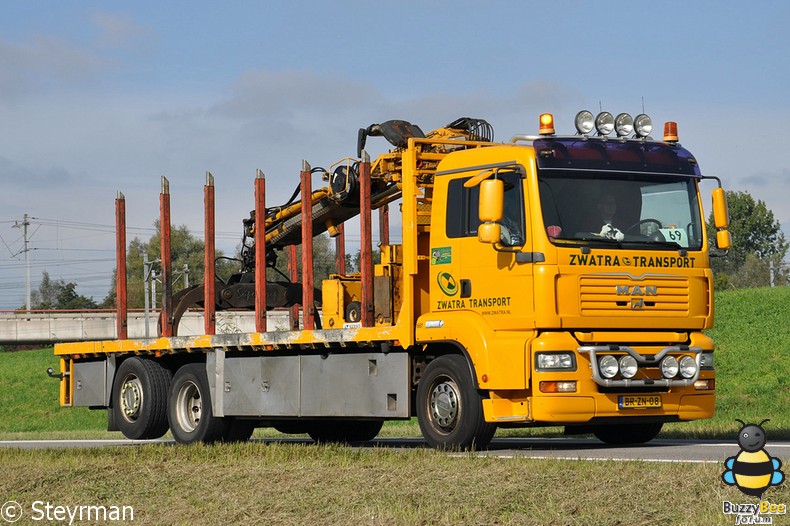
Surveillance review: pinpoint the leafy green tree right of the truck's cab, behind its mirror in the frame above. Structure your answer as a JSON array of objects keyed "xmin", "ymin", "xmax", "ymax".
[{"xmin": 707, "ymin": 191, "xmax": 790, "ymax": 288}]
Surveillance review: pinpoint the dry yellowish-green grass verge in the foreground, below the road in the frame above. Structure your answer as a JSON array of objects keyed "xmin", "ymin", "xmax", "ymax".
[{"xmin": 0, "ymin": 443, "xmax": 790, "ymax": 526}]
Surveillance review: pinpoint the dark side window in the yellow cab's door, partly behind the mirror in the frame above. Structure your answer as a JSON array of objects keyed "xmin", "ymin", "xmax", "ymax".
[{"xmin": 446, "ymin": 171, "xmax": 526, "ymax": 246}]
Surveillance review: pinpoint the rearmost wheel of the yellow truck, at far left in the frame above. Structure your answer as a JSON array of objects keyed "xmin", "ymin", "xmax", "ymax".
[{"xmin": 110, "ymin": 356, "xmax": 173, "ymax": 440}]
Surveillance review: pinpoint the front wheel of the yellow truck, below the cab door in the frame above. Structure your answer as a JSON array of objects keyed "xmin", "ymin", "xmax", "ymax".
[{"xmin": 417, "ymin": 354, "xmax": 496, "ymax": 450}]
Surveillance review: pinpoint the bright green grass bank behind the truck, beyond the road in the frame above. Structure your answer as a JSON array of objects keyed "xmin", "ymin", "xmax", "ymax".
[{"xmin": 0, "ymin": 287, "xmax": 790, "ymax": 440}]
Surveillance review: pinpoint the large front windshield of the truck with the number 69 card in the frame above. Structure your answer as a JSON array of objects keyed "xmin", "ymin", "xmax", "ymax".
[{"xmin": 538, "ymin": 170, "xmax": 703, "ymax": 250}]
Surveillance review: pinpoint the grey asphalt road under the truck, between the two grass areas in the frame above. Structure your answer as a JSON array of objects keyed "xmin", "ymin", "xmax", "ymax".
[{"xmin": 0, "ymin": 438, "xmax": 790, "ymax": 463}]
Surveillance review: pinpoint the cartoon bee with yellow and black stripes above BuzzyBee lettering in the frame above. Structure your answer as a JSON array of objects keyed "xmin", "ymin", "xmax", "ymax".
[{"xmin": 721, "ymin": 419, "xmax": 785, "ymax": 498}]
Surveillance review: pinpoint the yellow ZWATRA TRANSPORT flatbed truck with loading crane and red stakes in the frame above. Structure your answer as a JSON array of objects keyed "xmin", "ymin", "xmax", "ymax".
[{"xmin": 54, "ymin": 111, "xmax": 730, "ymax": 449}]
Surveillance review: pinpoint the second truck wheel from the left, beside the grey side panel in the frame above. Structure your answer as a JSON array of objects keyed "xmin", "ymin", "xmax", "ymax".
[{"xmin": 167, "ymin": 363, "xmax": 230, "ymax": 444}]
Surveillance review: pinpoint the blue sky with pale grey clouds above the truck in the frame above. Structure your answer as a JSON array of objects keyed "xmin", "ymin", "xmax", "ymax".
[{"xmin": 0, "ymin": 0, "xmax": 790, "ymax": 309}]
